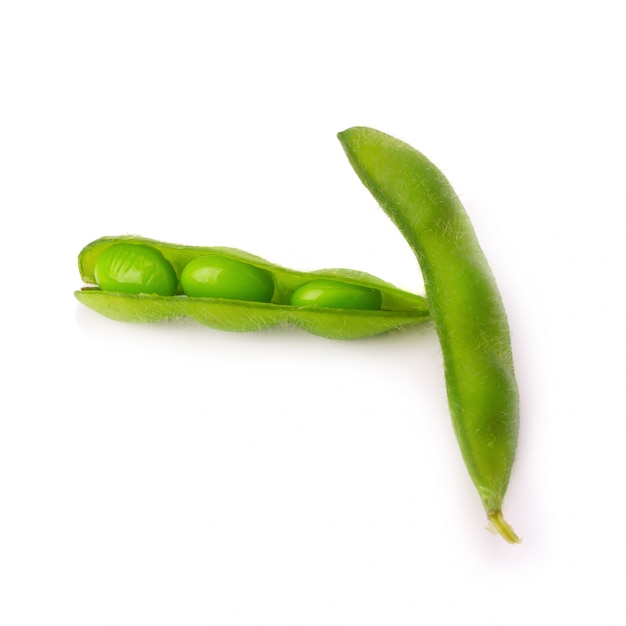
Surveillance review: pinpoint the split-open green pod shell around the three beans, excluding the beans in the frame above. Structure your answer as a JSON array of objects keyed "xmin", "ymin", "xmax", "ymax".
[{"xmin": 75, "ymin": 236, "xmax": 429, "ymax": 339}]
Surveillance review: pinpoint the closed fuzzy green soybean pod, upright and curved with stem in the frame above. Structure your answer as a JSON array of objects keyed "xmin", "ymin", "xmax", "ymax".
[{"xmin": 338, "ymin": 127, "xmax": 519, "ymax": 543}]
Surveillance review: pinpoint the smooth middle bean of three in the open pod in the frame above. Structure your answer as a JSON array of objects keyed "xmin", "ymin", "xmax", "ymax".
[{"xmin": 180, "ymin": 254, "xmax": 274, "ymax": 302}]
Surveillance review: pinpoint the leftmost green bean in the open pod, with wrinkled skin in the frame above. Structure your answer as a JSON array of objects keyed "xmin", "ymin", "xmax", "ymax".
[{"xmin": 94, "ymin": 243, "xmax": 178, "ymax": 296}]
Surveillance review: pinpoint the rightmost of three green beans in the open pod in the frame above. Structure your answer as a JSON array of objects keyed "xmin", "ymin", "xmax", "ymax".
[{"xmin": 291, "ymin": 280, "xmax": 381, "ymax": 311}]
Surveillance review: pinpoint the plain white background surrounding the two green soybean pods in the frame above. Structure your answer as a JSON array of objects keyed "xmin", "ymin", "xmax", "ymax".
[{"xmin": 0, "ymin": 0, "xmax": 626, "ymax": 626}]
